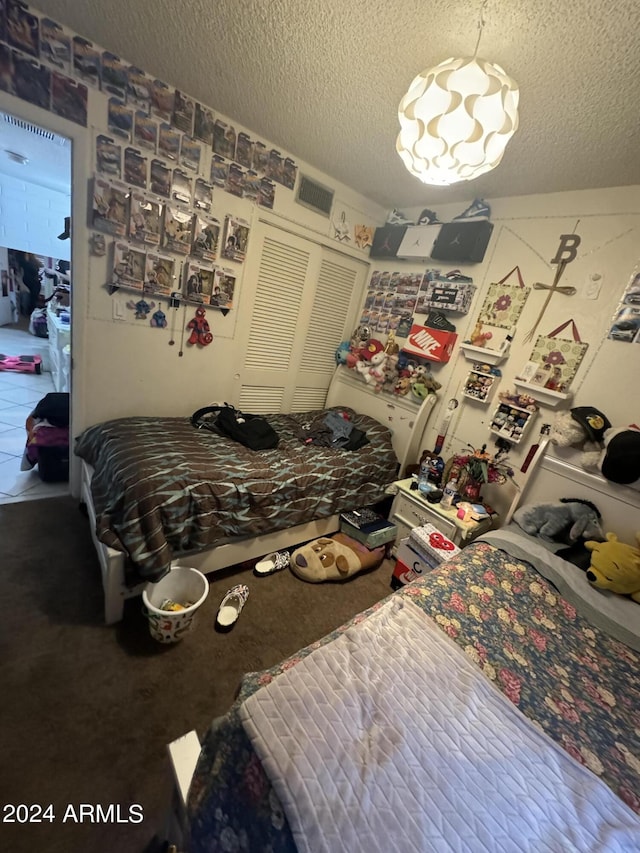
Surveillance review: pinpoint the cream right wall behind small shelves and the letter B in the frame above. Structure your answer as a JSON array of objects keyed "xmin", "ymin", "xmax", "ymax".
[{"xmin": 362, "ymin": 186, "xmax": 640, "ymax": 504}]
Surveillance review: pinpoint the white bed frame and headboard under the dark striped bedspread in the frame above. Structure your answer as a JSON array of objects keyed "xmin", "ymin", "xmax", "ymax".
[{"xmin": 80, "ymin": 367, "xmax": 436, "ymax": 625}]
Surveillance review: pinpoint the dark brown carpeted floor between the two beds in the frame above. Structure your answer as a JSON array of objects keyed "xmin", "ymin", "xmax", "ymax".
[{"xmin": 0, "ymin": 497, "xmax": 392, "ymax": 853}]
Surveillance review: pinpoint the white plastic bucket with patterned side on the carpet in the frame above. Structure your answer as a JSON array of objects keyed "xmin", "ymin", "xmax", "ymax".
[{"xmin": 142, "ymin": 566, "xmax": 209, "ymax": 643}]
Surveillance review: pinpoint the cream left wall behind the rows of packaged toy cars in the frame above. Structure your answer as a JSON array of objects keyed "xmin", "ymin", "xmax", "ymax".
[{"xmin": 0, "ymin": 6, "xmax": 385, "ymax": 490}]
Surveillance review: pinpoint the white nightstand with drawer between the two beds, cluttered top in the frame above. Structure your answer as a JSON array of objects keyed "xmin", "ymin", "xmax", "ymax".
[{"xmin": 389, "ymin": 478, "xmax": 497, "ymax": 548}]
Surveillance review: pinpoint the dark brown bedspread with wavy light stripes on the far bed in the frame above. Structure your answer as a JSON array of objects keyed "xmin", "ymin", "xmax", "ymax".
[{"xmin": 75, "ymin": 409, "xmax": 398, "ymax": 581}]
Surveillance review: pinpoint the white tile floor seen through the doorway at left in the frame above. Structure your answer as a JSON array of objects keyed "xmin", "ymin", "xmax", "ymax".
[{"xmin": 0, "ymin": 326, "xmax": 69, "ymax": 504}]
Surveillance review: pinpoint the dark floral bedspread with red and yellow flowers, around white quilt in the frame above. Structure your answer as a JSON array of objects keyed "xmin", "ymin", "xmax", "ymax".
[{"xmin": 189, "ymin": 542, "xmax": 640, "ymax": 853}]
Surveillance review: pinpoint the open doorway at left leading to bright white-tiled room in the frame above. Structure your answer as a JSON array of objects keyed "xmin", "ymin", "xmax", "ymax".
[{"xmin": 0, "ymin": 112, "xmax": 72, "ymax": 503}]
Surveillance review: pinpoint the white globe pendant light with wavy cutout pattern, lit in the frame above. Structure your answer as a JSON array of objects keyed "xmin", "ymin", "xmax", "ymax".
[{"xmin": 396, "ymin": 0, "xmax": 520, "ymax": 186}]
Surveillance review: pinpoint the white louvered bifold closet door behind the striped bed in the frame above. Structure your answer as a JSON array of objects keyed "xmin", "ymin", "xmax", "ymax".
[{"xmin": 234, "ymin": 222, "xmax": 368, "ymax": 414}]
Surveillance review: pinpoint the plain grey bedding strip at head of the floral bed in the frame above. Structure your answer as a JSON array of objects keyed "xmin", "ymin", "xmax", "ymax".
[{"xmin": 476, "ymin": 523, "xmax": 640, "ymax": 652}]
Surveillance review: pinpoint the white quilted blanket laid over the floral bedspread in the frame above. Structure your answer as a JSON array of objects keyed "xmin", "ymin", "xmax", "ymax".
[{"xmin": 240, "ymin": 598, "xmax": 640, "ymax": 853}]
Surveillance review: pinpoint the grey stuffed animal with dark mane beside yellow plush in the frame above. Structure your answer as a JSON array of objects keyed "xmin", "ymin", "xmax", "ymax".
[{"xmin": 513, "ymin": 498, "xmax": 605, "ymax": 545}]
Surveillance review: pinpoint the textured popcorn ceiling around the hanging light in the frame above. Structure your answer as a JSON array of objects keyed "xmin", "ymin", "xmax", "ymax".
[{"xmin": 27, "ymin": 0, "xmax": 640, "ymax": 208}]
